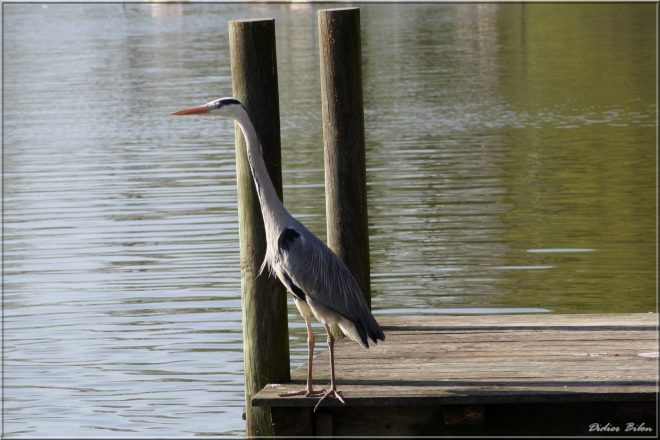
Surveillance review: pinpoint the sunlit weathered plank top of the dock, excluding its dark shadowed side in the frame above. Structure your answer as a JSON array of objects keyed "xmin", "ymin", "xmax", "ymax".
[{"xmin": 253, "ymin": 314, "xmax": 658, "ymax": 407}]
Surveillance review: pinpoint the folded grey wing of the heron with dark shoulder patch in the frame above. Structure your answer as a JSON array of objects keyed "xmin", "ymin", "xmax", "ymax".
[{"xmin": 278, "ymin": 221, "xmax": 373, "ymax": 321}]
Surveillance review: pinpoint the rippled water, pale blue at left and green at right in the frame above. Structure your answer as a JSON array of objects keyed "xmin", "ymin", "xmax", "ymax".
[{"xmin": 3, "ymin": 4, "xmax": 656, "ymax": 438}]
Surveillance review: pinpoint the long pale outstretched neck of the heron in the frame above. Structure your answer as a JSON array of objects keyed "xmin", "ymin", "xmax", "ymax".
[{"xmin": 236, "ymin": 111, "xmax": 289, "ymax": 241}]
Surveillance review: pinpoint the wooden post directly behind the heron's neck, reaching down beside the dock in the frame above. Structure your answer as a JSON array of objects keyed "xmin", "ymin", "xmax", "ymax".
[{"xmin": 229, "ymin": 19, "xmax": 290, "ymax": 436}]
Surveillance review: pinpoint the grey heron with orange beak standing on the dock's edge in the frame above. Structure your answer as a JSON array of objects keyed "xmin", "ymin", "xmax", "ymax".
[{"xmin": 173, "ymin": 98, "xmax": 385, "ymax": 410}]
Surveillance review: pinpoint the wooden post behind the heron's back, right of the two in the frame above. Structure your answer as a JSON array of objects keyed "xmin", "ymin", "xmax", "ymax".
[{"xmin": 318, "ymin": 8, "xmax": 371, "ymax": 316}]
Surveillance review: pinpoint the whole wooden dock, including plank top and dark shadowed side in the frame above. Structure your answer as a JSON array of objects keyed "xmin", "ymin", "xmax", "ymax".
[{"xmin": 252, "ymin": 313, "xmax": 658, "ymax": 437}]
